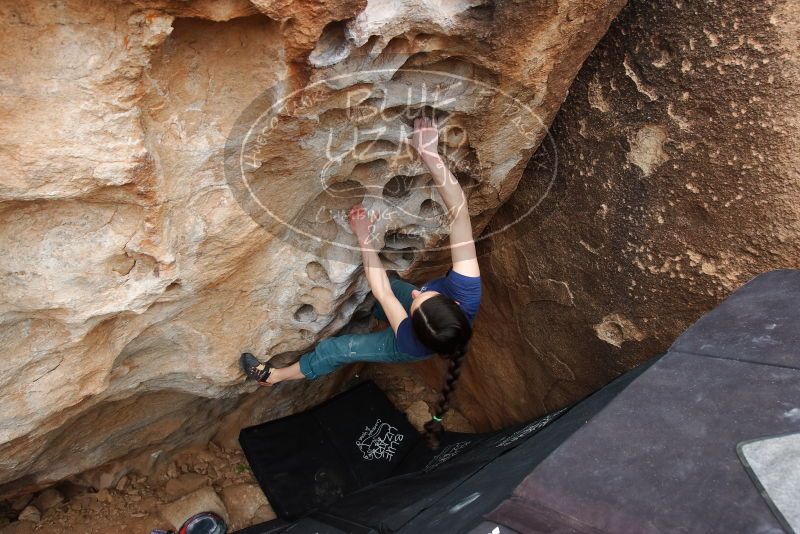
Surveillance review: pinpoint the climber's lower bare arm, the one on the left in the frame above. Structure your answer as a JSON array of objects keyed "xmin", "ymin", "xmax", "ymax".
[{"xmin": 347, "ymin": 204, "xmax": 408, "ymax": 334}]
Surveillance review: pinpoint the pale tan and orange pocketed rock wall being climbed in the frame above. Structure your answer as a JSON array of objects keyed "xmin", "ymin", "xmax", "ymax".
[{"xmin": 0, "ymin": 0, "xmax": 620, "ymax": 496}]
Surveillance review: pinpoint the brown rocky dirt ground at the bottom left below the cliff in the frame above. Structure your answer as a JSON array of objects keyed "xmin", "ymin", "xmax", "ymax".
[{"xmin": 0, "ymin": 443, "xmax": 275, "ymax": 534}]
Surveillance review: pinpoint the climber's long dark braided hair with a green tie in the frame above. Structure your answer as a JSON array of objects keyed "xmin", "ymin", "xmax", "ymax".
[{"xmin": 411, "ymin": 294, "xmax": 472, "ymax": 450}]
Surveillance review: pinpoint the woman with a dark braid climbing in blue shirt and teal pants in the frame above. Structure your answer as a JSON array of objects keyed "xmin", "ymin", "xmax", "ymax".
[{"xmin": 241, "ymin": 118, "xmax": 481, "ymax": 448}]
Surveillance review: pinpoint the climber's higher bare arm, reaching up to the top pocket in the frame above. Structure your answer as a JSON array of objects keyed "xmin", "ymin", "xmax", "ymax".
[{"xmin": 411, "ymin": 118, "xmax": 481, "ymax": 276}]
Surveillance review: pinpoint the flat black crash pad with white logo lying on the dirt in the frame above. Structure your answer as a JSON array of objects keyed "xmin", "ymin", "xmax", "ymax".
[{"xmin": 239, "ymin": 382, "xmax": 420, "ymax": 519}]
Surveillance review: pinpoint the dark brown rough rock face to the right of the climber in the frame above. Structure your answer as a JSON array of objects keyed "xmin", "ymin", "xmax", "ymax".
[{"xmin": 458, "ymin": 0, "xmax": 800, "ymax": 428}]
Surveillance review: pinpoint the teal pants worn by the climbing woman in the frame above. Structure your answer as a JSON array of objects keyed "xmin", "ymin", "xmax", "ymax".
[{"xmin": 300, "ymin": 278, "xmax": 429, "ymax": 379}]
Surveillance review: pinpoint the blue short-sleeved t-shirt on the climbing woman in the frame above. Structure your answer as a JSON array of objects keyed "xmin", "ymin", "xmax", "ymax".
[{"xmin": 396, "ymin": 268, "xmax": 481, "ymax": 358}]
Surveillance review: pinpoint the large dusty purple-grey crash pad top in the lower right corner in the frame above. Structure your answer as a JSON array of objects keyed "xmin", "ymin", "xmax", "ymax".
[{"xmin": 487, "ymin": 270, "xmax": 800, "ymax": 534}]
